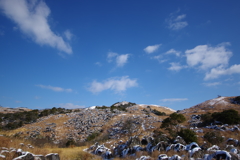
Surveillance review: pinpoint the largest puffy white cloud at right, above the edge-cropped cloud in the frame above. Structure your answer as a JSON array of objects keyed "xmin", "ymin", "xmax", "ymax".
[{"xmin": 185, "ymin": 43, "xmax": 232, "ymax": 70}]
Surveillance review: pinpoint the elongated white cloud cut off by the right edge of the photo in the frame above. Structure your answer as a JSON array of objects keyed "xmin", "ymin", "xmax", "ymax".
[{"xmin": 204, "ymin": 64, "xmax": 240, "ymax": 80}]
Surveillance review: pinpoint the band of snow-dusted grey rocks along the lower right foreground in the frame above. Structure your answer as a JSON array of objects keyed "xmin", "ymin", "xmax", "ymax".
[{"xmin": 86, "ymin": 136, "xmax": 240, "ymax": 160}]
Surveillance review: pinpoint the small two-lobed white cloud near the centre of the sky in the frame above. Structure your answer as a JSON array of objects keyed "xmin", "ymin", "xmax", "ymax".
[{"xmin": 107, "ymin": 52, "xmax": 130, "ymax": 67}]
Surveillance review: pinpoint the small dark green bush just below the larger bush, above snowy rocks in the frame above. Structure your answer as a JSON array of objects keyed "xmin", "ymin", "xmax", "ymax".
[{"xmin": 178, "ymin": 129, "xmax": 198, "ymax": 143}]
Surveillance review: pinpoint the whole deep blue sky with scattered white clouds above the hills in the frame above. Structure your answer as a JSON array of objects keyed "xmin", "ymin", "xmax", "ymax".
[{"xmin": 0, "ymin": 0, "xmax": 240, "ymax": 110}]
